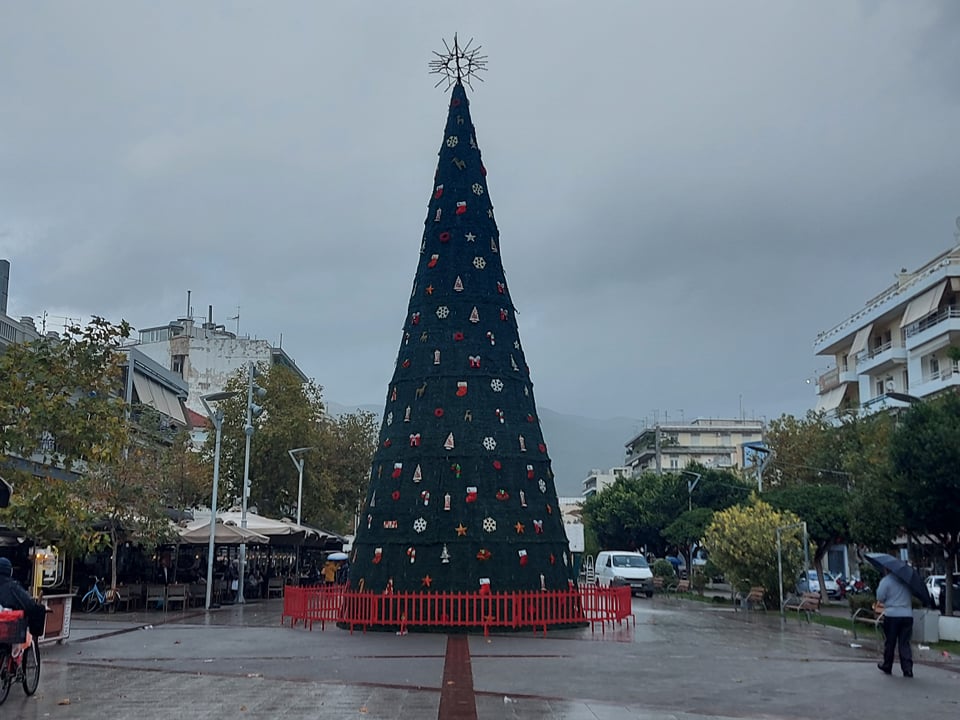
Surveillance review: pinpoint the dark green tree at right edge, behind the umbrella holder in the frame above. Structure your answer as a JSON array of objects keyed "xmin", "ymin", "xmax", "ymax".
[{"xmin": 889, "ymin": 393, "xmax": 960, "ymax": 612}]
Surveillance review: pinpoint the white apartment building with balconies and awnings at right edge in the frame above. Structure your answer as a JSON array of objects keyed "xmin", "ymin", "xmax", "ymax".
[{"xmin": 814, "ymin": 245, "xmax": 960, "ymax": 416}]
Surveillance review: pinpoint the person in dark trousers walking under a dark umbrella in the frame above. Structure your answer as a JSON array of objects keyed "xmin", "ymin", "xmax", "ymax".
[{"xmin": 866, "ymin": 553, "xmax": 931, "ymax": 677}]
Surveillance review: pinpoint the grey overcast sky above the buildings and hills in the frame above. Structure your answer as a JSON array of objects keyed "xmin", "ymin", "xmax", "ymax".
[{"xmin": 0, "ymin": 0, "xmax": 960, "ymax": 428}]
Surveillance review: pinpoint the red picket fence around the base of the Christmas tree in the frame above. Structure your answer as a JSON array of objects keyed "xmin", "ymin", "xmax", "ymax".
[{"xmin": 280, "ymin": 585, "xmax": 633, "ymax": 634}]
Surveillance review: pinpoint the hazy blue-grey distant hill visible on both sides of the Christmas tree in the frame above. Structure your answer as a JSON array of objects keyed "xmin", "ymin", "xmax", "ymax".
[{"xmin": 325, "ymin": 401, "xmax": 640, "ymax": 495}]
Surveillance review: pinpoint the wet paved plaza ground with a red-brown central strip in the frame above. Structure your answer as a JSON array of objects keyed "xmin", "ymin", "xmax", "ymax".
[{"xmin": 0, "ymin": 598, "xmax": 960, "ymax": 720}]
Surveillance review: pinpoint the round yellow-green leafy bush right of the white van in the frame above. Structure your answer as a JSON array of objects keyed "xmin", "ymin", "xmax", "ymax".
[{"xmin": 704, "ymin": 497, "xmax": 803, "ymax": 595}]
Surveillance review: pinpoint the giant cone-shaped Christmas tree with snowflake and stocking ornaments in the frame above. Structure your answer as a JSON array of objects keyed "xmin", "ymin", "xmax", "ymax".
[{"xmin": 350, "ymin": 45, "xmax": 574, "ymax": 593}]
